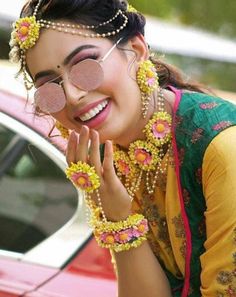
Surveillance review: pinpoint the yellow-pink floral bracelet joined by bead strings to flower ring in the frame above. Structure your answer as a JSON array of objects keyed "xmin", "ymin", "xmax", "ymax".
[{"xmin": 66, "ymin": 161, "xmax": 148, "ymax": 252}]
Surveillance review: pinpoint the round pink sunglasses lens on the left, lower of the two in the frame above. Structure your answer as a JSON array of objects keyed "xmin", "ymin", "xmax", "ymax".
[{"xmin": 34, "ymin": 83, "xmax": 66, "ymax": 113}]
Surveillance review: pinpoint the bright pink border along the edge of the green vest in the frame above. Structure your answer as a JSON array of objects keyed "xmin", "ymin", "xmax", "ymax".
[{"xmin": 168, "ymin": 86, "xmax": 192, "ymax": 297}]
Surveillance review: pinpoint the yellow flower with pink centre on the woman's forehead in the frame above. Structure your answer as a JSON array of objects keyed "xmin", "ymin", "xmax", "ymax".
[{"xmin": 12, "ymin": 16, "xmax": 40, "ymax": 50}]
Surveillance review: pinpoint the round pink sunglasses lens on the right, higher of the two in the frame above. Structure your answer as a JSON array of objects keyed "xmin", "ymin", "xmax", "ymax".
[{"xmin": 69, "ymin": 59, "xmax": 104, "ymax": 91}]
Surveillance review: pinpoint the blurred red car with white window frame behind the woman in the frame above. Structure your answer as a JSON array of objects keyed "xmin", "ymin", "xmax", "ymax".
[{"xmin": 0, "ymin": 91, "xmax": 116, "ymax": 297}]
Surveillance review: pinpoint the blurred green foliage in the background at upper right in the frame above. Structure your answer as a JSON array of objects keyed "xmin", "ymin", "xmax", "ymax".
[{"xmin": 129, "ymin": 0, "xmax": 236, "ymax": 92}]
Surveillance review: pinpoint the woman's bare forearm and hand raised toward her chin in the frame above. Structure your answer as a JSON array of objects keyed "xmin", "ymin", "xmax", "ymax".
[{"xmin": 67, "ymin": 127, "xmax": 171, "ymax": 297}]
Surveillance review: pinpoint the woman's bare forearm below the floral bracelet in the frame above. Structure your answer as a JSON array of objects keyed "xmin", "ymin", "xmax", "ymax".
[{"xmin": 114, "ymin": 241, "xmax": 171, "ymax": 297}]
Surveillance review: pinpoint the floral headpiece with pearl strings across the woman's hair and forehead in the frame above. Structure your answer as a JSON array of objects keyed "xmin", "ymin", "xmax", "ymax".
[{"xmin": 10, "ymin": 0, "xmax": 128, "ymax": 90}]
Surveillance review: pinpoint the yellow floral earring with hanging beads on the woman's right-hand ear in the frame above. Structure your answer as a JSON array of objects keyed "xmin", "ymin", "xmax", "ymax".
[{"xmin": 137, "ymin": 60, "xmax": 159, "ymax": 119}]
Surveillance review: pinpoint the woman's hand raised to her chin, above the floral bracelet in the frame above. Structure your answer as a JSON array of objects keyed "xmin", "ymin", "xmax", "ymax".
[{"xmin": 66, "ymin": 126, "xmax": 131, "ymax": 221}]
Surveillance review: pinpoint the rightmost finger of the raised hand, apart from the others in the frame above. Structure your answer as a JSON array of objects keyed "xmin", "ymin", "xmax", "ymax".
[{"xmin": 103, "ymin": 140, "xmax": 116, "ymax": 182}]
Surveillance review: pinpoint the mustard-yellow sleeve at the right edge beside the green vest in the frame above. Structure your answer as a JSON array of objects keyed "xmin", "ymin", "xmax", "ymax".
[{"xmin": 201, "ymin": 126, "xmax": 236, "ymax": 297}]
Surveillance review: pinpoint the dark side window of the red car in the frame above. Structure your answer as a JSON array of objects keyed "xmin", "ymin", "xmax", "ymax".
[{"xmin": 0, "ymin": 124, "xmax": 78, "ymax": 253}]
